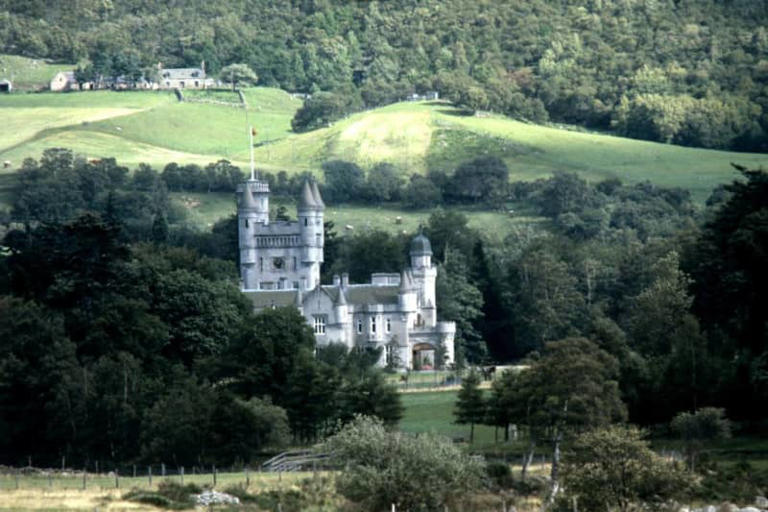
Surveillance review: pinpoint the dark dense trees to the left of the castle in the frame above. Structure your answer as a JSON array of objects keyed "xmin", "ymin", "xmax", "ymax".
[{"xmin": 0, "ymin": 150, "xmax": 402, "ymax": 467}]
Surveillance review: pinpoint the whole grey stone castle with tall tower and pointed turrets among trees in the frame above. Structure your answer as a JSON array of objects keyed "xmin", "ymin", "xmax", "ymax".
[{"xmin": 236, "ymin": 178, "xmax": 456, "ymax": 369}]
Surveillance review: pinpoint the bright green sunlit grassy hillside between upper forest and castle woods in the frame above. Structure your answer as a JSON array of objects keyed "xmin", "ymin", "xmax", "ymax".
[{"xmin": 0, "ymin": 88, "xmax": 768, "ymax": 200}]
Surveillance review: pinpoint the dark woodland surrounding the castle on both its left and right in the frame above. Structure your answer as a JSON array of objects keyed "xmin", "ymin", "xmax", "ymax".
[{"xmin": 0, "ymin": 149, "xmax": 768, "ymax": 472}]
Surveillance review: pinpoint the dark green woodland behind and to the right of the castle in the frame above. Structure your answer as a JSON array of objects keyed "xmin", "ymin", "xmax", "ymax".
[{"xmin": 325, "ymin": 163, "xmax": 768, "ymax": 425}]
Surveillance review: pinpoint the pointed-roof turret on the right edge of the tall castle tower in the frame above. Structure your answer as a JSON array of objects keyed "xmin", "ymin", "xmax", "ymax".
[{"xmin": 296, "ymin": 181, "xmax": 325, "ymax": 289}]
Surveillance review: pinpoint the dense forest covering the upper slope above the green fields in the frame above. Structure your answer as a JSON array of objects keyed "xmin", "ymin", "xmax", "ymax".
[{"xmin": 0, "ymin": 0, "xmax": 768, "ymax": 151}]
